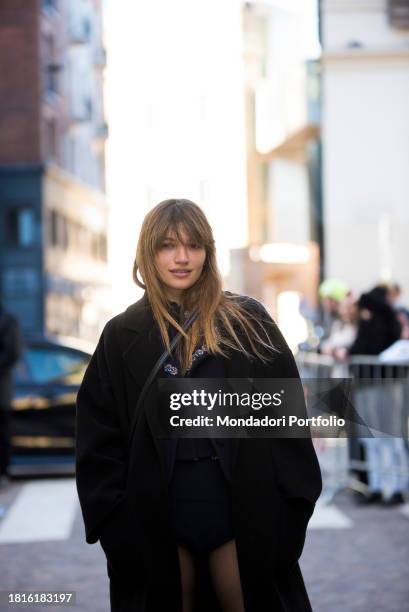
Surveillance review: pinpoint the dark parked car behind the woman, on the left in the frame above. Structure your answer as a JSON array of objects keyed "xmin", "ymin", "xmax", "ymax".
[{"xmin": 10, "ymin": 336, "xmax": 93, "ymax": 476}]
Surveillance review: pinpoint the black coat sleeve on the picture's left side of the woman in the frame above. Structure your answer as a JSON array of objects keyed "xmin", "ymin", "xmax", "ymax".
[{"xmin": 76, "ymin": 323, "xmax": 127, "ymax": 544}]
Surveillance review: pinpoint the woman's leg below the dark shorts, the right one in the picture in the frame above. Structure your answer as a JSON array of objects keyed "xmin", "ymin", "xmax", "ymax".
[{"xmin": 209, "ymin": 540, "xmax": 245, "ymax": 612}]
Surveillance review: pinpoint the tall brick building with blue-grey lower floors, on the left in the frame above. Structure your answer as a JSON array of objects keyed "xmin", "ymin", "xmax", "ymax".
[{"xmin": 0, "ymin": 0, "xmax": 110, "ymax": 341}]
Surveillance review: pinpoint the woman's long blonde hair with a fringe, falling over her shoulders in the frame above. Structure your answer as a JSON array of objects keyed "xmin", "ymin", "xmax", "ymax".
[{"xmin": 132, "ymin": 199, "xmax": 276, "ymax": 372}]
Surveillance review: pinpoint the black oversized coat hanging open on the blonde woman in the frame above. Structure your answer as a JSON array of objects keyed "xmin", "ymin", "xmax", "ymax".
[{"xmin": 76, "ymin": 294, "xmax": 321, "ymax": 612}]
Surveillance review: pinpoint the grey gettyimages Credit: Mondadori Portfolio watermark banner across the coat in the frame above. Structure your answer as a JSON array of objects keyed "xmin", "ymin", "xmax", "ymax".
[{"xmin": 156, "ymin": 378, "xmax": 408, "ymax": 438}]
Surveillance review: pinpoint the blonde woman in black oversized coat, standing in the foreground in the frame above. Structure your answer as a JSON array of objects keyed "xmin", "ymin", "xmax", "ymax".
[{"xmin": 77, "ymin": 200, "xmax": 321, "ymax": 612}]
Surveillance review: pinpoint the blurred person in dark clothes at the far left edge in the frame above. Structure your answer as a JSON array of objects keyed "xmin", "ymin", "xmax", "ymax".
[{"xmin": 0, "ymin": 301, "xmax": 22, "ymax": 487}]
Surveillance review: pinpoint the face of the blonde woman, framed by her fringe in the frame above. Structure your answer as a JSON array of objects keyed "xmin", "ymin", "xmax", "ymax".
[{"xmin": 155, "ymin": 228, "xmax": 206, "ymax": 302}]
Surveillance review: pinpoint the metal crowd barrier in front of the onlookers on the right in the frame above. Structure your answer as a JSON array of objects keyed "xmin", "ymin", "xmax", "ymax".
[{"xmin": 296, "ymin": 351, "xmax": 409, "ymax": 504}]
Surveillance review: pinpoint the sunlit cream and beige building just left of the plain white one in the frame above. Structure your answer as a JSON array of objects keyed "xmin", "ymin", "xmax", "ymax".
[{"xmin": 230, "ymin": 0, "xmax": 322, "ymax": 345}]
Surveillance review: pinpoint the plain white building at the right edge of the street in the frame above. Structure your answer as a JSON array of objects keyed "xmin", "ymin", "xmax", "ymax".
[{"xmin": 321, "ymin": 0, "xmax": 409, "ymax": 298}]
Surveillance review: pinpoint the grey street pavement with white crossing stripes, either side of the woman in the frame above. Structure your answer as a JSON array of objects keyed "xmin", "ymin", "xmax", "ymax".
[{"xmin": 0, "ymin": 478, "xmax": 409, "ymax": 612}]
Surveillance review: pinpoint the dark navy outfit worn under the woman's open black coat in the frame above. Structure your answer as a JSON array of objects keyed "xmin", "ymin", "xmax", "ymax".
[{"xmin": 162, "ymin": 312, "xmax": 234, "ymax": 556}]
